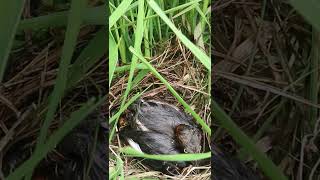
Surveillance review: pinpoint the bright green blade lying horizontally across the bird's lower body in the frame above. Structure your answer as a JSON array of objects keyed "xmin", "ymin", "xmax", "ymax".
[{"xmin": 120, "ymin": 147, "xmax": 211, "ymax": 161}]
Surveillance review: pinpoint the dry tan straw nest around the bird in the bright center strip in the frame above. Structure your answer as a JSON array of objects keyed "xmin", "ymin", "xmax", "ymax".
[{"xmin": 109, "ymin": 39, "xmax": 211, "ymax": 179}]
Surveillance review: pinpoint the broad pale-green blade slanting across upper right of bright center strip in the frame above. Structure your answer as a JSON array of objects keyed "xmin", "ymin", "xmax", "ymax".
[{"xmin": 148, "ymin": 0, "xmax": 211, "ymax": 71}]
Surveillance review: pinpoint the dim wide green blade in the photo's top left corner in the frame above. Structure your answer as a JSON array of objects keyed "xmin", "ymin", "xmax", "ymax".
[{"xmin": 0, "ymin": 0, "xmax": 24, "ymax": 83}]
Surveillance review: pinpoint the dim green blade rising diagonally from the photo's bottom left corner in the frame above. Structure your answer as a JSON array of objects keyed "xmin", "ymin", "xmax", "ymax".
[{"xmin": 6, "ymin": 96, "xmax": 106, "ymax": 180}]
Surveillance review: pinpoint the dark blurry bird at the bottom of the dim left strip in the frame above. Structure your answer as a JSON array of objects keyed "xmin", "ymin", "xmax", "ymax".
[{"xmin": 34, "ymin": 115, "xmax": 108, "ymax": 180}]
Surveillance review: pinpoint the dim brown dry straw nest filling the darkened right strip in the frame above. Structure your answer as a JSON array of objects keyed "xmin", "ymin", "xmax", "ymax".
[{"xmin": 212, "ymin": 0, "xmax": 320, "ymax": 179}]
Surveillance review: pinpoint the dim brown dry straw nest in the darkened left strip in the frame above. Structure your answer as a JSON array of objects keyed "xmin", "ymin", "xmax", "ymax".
[{"xmin": 0, "ymin": 23, "xmax": 107, "ymax": 179}]
